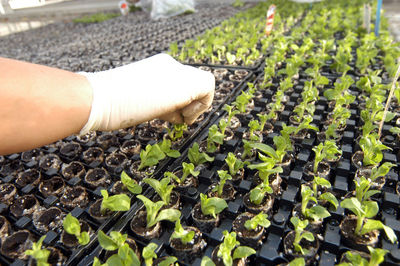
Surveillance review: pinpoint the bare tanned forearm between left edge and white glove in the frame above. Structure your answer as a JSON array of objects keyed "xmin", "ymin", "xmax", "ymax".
[{"xmin": 0, "ymin": 58, "xmax": 92, "ymax": 154}]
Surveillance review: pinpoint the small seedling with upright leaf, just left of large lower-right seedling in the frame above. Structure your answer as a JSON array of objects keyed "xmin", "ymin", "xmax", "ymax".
[{"xmin": 301, "ymin": 185, "xmax": 331, "ymax": 221}]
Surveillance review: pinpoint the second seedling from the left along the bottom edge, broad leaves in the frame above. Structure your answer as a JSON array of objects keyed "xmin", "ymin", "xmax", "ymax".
[{"xmin": 93, "ymin": 230, "xmax": 140, "ymax": 266}]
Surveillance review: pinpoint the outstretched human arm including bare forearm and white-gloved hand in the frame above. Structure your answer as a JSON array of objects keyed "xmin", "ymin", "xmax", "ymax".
[{"xmin": 0, "ymin": 55, "xmax": 215, "ymax": 154}]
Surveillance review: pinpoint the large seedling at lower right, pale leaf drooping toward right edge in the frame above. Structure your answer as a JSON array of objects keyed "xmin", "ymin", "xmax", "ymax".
[{"xmin": 340, "ymin": 197, "xmax": 397, "ymax": 243}]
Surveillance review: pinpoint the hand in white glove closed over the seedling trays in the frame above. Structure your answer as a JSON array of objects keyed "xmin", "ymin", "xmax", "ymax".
[{"xmin": 79, "ymin": 54, "xmax": 215, "ymax": 135}]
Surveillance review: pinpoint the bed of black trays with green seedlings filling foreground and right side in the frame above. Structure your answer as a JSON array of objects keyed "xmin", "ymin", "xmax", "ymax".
[{"xmin": 0, "ymin": 0, "xmax": 400, "ymax": 265}]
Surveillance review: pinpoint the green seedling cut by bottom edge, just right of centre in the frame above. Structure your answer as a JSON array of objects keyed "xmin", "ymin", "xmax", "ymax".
[{"xmin": 217, "ymin": 230, "xmax": 256, "ymax": 266}]
